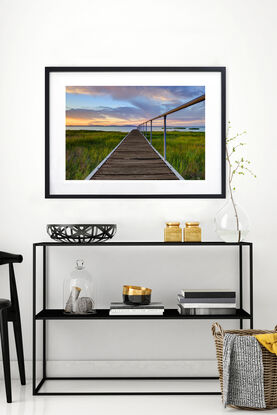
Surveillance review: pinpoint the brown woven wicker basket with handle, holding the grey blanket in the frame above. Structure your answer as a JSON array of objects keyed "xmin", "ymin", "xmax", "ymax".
[{"xmin": 212, "ymin": 323, "xmax": 277, "ymax": 409}]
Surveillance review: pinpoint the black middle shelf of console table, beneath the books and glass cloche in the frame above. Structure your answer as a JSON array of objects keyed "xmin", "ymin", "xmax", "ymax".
[{"xmin": 35, "ymin": 308, "xmax": 251, "ymax": 320}]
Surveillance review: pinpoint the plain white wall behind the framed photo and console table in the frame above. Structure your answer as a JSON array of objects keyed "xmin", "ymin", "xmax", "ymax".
[{"xmin": 0, "ymin": 0, "xmax": 277, "ymax": 376}]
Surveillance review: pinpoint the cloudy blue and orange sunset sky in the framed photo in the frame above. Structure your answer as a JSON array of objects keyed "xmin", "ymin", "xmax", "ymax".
[{"xmin": 66, "ymin": 86, "xmax": 205, "ymax": 126}]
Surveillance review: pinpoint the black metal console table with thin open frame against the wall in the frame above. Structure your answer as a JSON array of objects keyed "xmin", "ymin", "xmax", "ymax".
[{"xmin": 33, "ymin": 242, "xmax": 253, "ymax": 395}]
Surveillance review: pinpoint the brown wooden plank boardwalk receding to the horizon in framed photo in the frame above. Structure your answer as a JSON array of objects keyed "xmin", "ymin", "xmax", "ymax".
[{"xmin": 90, "ymin": 130, "xmax": 179, "ymax": 180}]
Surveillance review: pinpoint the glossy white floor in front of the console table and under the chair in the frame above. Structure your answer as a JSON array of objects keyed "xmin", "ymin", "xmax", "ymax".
[{"xmin": 0, "ymin": 380, "xmax": 277, "ymax": 415}]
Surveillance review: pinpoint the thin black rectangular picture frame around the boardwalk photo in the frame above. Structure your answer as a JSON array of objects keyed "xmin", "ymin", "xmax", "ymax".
[{"xmin": 45, "ymin": 66, "xmax": 226, "ymax": 199}]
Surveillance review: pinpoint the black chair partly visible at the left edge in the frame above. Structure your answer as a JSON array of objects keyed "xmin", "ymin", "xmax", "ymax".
[{"xmin": 0, "ymin": 251, "xmax": 26, "ymax": 403}]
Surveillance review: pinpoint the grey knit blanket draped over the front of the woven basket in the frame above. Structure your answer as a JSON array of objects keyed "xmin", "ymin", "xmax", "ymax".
[{"xmin": 223, "ymin": 333, "xmax": 266, "ymax": 408}]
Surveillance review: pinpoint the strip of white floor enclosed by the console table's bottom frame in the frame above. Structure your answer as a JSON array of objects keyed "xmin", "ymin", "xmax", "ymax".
[{"xmin": 34, "ymin": 377, "xmax": 220, "ymax": 395}]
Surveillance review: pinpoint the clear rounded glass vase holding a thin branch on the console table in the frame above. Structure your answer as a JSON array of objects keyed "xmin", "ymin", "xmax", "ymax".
[{"xmin": 212, "ymin": 196, "xmax": 249, "ymax": 242}]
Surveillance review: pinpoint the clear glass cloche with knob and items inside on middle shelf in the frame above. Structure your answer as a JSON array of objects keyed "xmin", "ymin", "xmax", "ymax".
[{"xmin": 64, "ymin": 259, "xmax": 96, "ymax": 314}]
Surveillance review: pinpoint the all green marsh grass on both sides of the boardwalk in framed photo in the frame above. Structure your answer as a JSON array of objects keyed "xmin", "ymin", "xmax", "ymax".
[{"xmin": 66, "ymin": 130, "xmax": 205, "ymax": 180}]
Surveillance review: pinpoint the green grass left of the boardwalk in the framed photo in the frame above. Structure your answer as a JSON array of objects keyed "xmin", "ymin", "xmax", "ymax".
[{"xmin": 66, "ymin": 130, "xmax": 126, "ymax": 180}]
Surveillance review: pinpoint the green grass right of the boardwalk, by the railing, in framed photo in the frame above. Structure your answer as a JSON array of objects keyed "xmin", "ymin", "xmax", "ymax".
[{"xmin": 148, "ymin": 131, "xmax": 205, "ymax": 180}]
